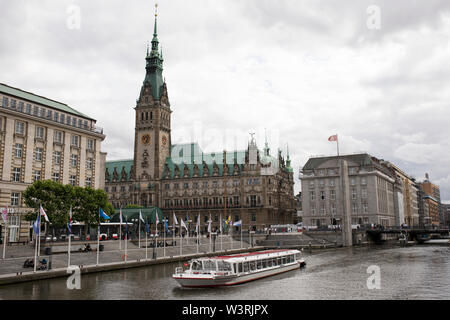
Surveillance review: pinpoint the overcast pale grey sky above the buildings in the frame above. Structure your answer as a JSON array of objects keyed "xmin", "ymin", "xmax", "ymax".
[{"xmin": 0, "ymin": 0, "xmax": 450, "ymax": 203}]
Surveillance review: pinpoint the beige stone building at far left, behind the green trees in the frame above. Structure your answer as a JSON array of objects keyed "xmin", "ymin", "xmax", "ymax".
[{"xmin": 0, "ymin": 83, "xmax": 106, "ymax": 243}]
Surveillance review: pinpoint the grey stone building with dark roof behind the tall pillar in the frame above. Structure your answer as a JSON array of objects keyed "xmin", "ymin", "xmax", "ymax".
[{"xmin": 300, "ymin": 154, "xmax": 399, "ymax": 227}]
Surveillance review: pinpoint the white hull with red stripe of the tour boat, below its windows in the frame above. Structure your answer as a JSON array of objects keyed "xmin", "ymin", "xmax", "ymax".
[{"xmin": 173, "ymin": 261, "xmax": 305, "ymax": 288}]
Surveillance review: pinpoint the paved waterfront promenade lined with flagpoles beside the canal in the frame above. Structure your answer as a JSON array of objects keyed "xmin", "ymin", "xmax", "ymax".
[{"xmin": 0, "ymin": 236, "xmax": 251, "ymax": 285}]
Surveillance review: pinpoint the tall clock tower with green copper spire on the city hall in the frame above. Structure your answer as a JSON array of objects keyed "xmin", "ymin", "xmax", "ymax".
[{"xmin": 134, "ymin": 6, "xmax": 172, "ymax": 205}]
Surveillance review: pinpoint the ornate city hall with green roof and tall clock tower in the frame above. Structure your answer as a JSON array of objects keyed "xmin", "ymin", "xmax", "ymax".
[{"xmin": 105, "ymin": 17, "xmax": 296, "ymax": 230}]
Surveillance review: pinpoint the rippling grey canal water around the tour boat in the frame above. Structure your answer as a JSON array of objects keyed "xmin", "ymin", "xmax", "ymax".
[{"xmin": 0, "ymin": 246, "xmax": 450, "ymax": 300}]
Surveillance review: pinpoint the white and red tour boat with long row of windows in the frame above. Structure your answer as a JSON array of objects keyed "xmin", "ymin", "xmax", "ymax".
[{"xmin": 172, "ymin": 249, "xmax": 306, "ymax": 287}]
